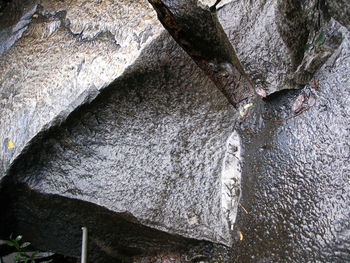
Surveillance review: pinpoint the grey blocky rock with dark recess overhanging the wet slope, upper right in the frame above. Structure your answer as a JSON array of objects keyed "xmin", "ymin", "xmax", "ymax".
[{"xmin": 218, "ymin": 0, "xmax": 341, "ymax": 95}]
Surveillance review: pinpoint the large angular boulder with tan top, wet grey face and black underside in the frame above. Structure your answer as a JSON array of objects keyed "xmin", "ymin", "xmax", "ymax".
[{"xmin": 0, "ymin": 1, "xmax": 240, "ymax": 262}]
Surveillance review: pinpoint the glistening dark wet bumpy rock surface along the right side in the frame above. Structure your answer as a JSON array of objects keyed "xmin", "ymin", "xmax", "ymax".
[{"xmin": 233, "ymin": 25, "xmax": 350, "ymax": 263}]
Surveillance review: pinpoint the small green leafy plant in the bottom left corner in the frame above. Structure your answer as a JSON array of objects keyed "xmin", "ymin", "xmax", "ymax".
[{"xmin": 5, "ymin": 234, "xmax": 47, "ymax": 263}]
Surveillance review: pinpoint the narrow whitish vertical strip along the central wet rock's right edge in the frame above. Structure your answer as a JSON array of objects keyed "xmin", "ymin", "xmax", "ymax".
[{"xmin": 221, "ymin": 131, "xmax": 242, "ymax": 231}]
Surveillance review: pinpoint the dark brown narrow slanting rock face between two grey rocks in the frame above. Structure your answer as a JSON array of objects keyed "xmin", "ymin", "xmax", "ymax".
[{"xmin": 149, "ymin": 0, "xmax": 254, "ymax": 107}]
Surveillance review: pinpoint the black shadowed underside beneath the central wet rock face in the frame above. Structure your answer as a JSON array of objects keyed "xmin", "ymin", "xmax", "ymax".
[{"xmin": 0, "ymin": 177, "xmax": 199, "ymax": 262}]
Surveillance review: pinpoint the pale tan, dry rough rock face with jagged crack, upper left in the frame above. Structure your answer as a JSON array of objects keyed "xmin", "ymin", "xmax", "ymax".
[{"xmin": 0, "ymin": 1, "xmax": 163, "ymax": 180}]
